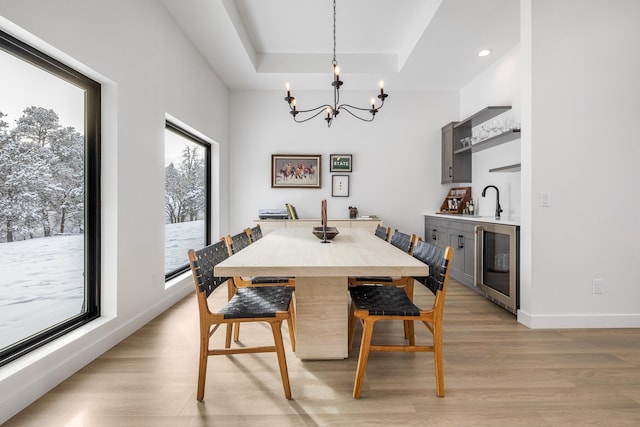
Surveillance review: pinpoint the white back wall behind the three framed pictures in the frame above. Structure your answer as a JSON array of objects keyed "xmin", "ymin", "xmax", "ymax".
[{"xmin": 230, "ymin": 89, "xmax": 458, "ymax": 236}]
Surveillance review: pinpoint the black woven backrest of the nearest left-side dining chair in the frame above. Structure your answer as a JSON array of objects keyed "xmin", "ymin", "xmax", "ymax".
[{"xmin": 189, "ymin": 240, "xmax": 229, "ymax": 297}]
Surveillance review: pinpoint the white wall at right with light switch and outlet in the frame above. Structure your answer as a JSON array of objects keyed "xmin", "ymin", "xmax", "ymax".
[{"xmin": 518, "ymin": 0, "xmax": 640, "ymax": 327}]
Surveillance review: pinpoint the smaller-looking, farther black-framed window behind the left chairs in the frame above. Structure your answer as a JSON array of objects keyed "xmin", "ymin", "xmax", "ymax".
[{"xmin": 164, "ymin": 121, "xmax": 211, "ymax": 279}]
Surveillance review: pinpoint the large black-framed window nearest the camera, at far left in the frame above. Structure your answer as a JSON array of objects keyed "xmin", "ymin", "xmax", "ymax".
[{"xmin": 0, "ymin": 32, "xmax": 100, "ymax": 365}]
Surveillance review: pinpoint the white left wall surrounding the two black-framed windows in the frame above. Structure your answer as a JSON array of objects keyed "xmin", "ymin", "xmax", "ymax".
[{"xmin": 0, "ymin": 0, "xmax": 229, "ymax": 423}]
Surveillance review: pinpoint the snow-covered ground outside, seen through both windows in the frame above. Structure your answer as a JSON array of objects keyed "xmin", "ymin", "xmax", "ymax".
[{"xmin": 0, "ymin": 221, "xmax": 204, "ymax": 349}]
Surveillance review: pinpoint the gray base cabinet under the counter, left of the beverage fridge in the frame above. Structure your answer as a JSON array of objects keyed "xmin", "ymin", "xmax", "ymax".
[{"xmin": 424, "ymin": 216, "xmax": 476, "ymax": 290}]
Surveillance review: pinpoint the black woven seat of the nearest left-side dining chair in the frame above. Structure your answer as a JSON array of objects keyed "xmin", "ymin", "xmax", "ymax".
[{"xmin": 220, "ymin": 286, "xmax": 293, "ymax": 319}]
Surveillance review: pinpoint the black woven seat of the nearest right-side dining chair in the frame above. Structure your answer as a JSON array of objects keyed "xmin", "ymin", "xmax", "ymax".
[{"xmin": 349, "ymin": 286, "xmax": 420, "ymax": 316}]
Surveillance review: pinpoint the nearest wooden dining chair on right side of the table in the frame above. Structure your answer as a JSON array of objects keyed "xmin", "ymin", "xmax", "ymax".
[{"xmin": 348, "ymin": 240, "xmax": 453, "ymax": 399}]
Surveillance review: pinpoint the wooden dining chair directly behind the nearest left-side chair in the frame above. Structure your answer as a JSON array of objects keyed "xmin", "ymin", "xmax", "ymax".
[{"xmin": 220, "ymin": 231, "xmax": 296, "ymax": 351}]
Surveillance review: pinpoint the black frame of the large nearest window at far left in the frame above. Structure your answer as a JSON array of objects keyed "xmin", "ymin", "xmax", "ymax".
[{"xmin": 0, "ymin": 30, "xmax": 101, "ymax": 366}]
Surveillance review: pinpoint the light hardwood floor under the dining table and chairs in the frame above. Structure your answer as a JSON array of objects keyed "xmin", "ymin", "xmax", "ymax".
[{"xmin": 5, "ymin": 281, "xmax": 640, "ymax": 427}]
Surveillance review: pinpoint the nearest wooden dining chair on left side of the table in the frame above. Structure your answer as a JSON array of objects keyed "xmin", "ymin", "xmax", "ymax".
[{"xmin": 189, "ymin": 241, "xmax": 293, "ymax": 401}]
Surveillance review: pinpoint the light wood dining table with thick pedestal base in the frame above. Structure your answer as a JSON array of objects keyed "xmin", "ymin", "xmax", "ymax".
[{"xmin": 214, "ymin": 227, "xmax": 429, "ymax": 359}]
